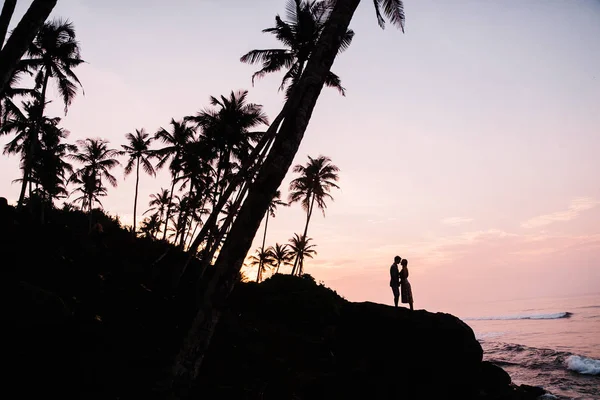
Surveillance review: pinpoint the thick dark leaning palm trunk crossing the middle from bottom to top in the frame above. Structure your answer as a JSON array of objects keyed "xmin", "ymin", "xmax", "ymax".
[{"xmin": 164, "ymin": 0, "xmax": 360, "ymax": 398}]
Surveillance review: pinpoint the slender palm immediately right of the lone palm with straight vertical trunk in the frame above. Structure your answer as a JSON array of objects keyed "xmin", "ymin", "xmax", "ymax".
[{"xmin": 154, "ymin": 119, "xmax": 196, "ymax": 240}]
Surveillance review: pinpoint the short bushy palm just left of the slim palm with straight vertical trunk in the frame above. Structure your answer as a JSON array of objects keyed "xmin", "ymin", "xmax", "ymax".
[{"xmin": 70, "ymin": 139, "xmax": 121, "ymax": 229}]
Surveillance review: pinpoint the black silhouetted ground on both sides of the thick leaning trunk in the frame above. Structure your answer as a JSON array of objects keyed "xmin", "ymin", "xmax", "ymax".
[{"xmin": 0, "ymin": 205, "xmax": 543, "ymax": 400}]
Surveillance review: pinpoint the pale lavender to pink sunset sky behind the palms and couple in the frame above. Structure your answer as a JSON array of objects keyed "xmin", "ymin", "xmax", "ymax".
[{"xmin": 0, "ymin": 0, "xmax": 600, "ymax": 312}]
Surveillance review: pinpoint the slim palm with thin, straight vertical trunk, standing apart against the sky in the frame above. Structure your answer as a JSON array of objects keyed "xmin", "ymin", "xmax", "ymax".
[{"xmin": 121, "ymin": 128, "xmax": 156, "ymax": 235}]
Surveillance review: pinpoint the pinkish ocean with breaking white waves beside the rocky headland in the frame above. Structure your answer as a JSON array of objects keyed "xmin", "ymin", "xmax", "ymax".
[{"xmin": 460, "ymin": 294, "xmax": 600, "ymax": 400}]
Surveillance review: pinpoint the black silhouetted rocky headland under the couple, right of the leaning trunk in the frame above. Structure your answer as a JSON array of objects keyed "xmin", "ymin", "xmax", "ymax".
[{"xmin": 198, "ymin": 275, "xmax": 539, "ymax": 400}]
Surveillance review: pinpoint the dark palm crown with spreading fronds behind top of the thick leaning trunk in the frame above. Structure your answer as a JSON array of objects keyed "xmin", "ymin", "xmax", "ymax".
[{"xmin": 240, "ymin": 0, "xmax": 354, "ymax": 96}]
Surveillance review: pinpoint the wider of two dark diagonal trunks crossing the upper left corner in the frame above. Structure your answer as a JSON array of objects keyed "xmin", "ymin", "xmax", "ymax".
[{"xmin": 0, "ymin": 0, "xmax": 57, "ymax": 95}]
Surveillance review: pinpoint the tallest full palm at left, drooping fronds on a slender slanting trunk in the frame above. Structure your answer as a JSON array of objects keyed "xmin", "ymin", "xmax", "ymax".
[{"xmin": 18, "ymin": 19, "xmax": 84, "ymax": 206}]
